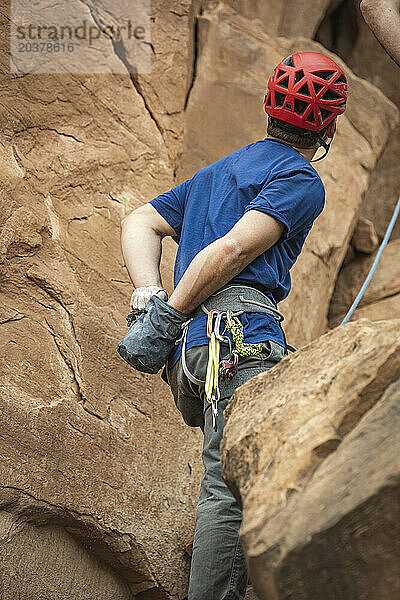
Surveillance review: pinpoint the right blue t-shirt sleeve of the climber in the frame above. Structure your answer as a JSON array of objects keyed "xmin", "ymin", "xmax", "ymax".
[{"xmin": 245, "ymin": 170, "xmax": 325, "ymax": 240}]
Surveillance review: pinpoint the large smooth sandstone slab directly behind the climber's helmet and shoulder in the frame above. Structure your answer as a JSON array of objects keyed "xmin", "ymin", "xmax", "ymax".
[{"xmin": 177, "ymin": 5, "xmax": 397, "ymax": 346}]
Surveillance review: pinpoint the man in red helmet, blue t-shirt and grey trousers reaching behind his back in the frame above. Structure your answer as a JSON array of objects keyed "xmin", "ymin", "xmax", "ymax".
[{"xmin": 118, "ymin": 52, "xmax": 347, "ymax": 600}]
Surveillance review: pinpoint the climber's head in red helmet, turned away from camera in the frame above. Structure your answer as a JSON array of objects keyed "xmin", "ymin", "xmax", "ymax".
[{"xmin": 264, "ymin": 52, "xmax": 347, "ymax": 155}]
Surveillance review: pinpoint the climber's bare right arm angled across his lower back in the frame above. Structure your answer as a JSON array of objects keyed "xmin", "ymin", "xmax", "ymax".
[{"xmin": 168, "ymin": 210, "xmax": 284, "ymax": 314}]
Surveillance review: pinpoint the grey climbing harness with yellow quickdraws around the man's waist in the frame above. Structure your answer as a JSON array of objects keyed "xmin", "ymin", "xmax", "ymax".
[{"xmin": 175, "ymin": 285, "xmax": 294, "ymax": 431}]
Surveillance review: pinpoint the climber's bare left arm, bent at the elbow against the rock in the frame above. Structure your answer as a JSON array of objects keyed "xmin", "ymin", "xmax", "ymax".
[{"xmin": 121, "ymin": 204, "xmax": 176, "ymax": 288}]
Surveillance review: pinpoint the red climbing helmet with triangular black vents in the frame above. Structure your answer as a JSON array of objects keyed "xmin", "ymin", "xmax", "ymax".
[{"xmin": 264, "ymin": 52, "xmax": 347, "ymax": 131}]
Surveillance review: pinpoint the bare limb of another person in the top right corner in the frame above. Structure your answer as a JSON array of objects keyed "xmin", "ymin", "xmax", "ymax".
[{"xmin": 360, "ymin": 0, "xmax": 400, "ymax": 66}]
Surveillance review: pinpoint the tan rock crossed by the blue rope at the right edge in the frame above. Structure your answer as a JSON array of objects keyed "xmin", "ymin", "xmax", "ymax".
[{"xmin": 329, "ymin": 239, "xmax": 400, "ymax": 327}]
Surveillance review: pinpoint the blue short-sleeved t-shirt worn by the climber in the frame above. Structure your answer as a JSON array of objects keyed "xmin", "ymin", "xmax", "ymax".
[{"xmin": 150, "ymin": 138, "xmax": 325, "ymax": 381}]
